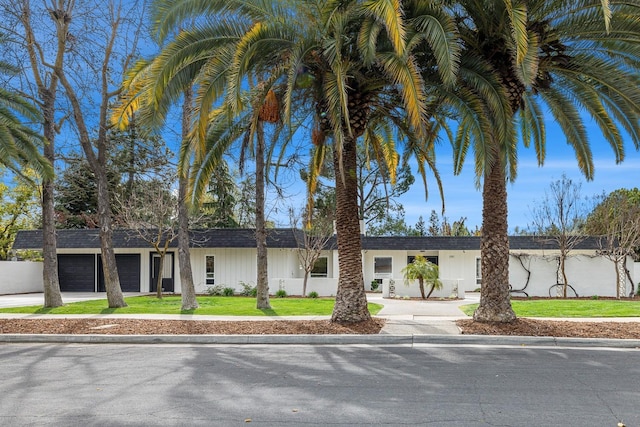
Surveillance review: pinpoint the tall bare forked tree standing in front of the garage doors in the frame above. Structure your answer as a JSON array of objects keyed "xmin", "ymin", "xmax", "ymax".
[{"xmin": 50, "ymin": 0, "xmax": 142, "ymax": 307}]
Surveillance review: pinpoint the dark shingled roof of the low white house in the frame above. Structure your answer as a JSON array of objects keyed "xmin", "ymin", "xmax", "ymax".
[{"xmin": 13, "ymin": 228, "xmax": 601, "ymax": 251}]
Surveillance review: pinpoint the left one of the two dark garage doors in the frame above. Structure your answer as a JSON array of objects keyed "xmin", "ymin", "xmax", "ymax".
[{"xmin": 58, "ymin": 254, "xmax": 96, "ymax": 292}]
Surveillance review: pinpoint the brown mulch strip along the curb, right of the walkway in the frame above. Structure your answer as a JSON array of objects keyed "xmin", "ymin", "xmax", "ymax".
[{"xmin": 456, "ymin": 319, "xmax": 640, "ymax": 339}]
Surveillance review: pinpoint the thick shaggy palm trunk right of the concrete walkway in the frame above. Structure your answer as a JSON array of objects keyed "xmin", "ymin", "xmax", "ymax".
[{"xmin": 473, "ymin": 161, "xmax": 516, "ymax": 323}]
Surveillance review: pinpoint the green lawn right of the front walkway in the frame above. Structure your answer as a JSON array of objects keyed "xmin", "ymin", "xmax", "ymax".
[{"xmin": 460, "ymin": 299, "xmax": 640, "ymax": 317}]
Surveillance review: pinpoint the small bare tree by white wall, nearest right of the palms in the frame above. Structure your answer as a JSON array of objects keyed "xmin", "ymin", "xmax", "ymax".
[{"xmin": 530, "ymin": 174, "xmax": 587, "ymax": 298}]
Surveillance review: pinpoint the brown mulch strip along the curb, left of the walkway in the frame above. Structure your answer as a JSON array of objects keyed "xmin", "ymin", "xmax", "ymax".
[{"xmin": 0, "ymin": 318, "xmax": 385, "ymax": 335}]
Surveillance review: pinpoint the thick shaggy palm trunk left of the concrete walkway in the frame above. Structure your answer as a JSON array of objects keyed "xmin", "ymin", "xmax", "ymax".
[{"xmin": 331, "ymin": 137, "xmax": 371, "ymax": 323}]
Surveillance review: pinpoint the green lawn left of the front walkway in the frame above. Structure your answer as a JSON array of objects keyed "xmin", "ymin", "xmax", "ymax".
[{"xmin": 0, "ymin": 295, "xmax": 382, "ymax": 316}]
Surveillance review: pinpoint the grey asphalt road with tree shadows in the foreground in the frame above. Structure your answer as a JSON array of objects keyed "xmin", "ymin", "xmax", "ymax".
[{"xmin": 0, "ymin": 344, "xmax": 640, "ymax": 427}]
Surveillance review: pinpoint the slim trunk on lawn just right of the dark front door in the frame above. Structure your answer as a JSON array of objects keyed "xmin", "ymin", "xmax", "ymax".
[{"xmin": 178, "ymin": 89, "xmax": 199, "ymax": 310}]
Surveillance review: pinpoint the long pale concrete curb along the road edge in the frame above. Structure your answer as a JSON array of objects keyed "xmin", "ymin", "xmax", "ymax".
[{"xmin": 0, "ymin": 334, "xmax": 640, "ymax": 349}]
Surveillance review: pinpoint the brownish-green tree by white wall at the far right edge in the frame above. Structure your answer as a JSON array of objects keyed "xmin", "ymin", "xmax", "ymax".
[{"xmin": 584, "ymin": 188, "xmax": 640, "ymax": 298}]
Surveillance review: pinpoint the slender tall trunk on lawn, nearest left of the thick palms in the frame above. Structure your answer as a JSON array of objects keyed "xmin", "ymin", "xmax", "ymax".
[{"xmin": 256, "ymin": 121, "xmax": 271, "ymax": 309}]
